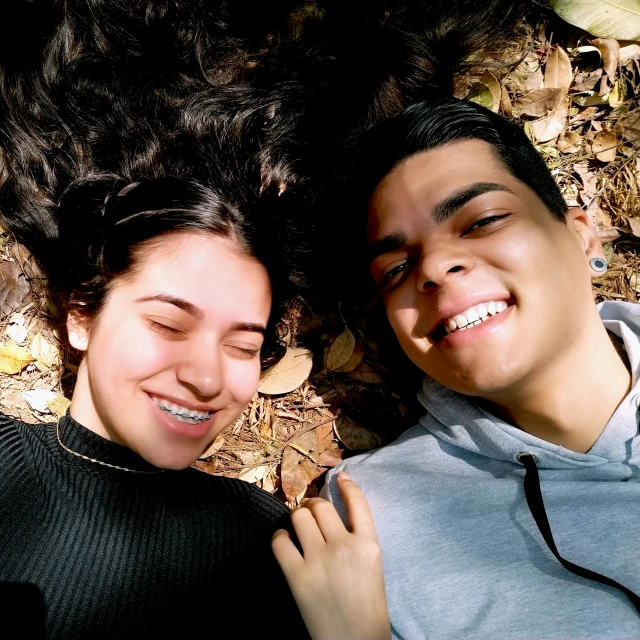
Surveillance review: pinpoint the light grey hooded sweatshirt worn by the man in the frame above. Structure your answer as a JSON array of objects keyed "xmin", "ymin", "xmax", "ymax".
[{"xmin": 324, "ymin": 302, "xmax": 640, "ymax": 640}]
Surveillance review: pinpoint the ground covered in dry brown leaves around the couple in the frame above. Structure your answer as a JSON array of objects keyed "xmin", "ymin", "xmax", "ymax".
[{"xmin": 0, "ymin": 10, "xmax": 640, "ymax": 506}]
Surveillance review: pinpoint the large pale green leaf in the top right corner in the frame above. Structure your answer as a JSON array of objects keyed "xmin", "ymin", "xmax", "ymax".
[{"xmin": 551, "ymin": 0, "xmax": 640, "ymax": 40}]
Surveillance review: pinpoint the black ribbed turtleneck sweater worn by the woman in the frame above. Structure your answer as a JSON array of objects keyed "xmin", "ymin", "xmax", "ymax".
[{"xmin": 0, "ymin": 414, "xmax": 306, "ymax": 640}]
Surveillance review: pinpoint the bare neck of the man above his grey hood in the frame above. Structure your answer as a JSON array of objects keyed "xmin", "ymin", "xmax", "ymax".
[{"xmin": 480, "ymin": 320, "xmax": 631, "ymax": 453}]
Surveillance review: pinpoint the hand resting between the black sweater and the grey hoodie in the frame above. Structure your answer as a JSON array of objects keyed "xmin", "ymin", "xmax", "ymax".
[{"xmin": 271, "ymin": 471, "xmax": 391, "ymax": 640}]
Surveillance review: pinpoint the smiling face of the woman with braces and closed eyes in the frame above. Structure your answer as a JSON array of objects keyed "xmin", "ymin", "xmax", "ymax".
[{"xmin": 67, "ymin": 233, "xmax": 271, "ymax": 469}]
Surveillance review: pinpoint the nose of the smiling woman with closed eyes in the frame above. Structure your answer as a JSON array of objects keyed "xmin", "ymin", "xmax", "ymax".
[{"xmin": 177, "ymin": 339, "xmax": 225, "ymax": 398}]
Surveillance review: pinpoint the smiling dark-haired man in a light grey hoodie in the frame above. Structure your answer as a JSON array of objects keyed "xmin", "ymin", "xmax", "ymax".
[{"xmin": 325, "ymin": 99, "xmax": 640, "ymax": 640}]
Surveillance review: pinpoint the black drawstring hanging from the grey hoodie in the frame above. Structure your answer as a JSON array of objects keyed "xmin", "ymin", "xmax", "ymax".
[{"xmin": 518, "ymin": 452, "xmax": 640, "ymax": 613}]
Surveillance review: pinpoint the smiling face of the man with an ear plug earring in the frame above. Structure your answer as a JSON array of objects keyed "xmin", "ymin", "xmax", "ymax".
[{"xmin": 367, "ymin": 140, "xmax": 602, "ymax": 399}]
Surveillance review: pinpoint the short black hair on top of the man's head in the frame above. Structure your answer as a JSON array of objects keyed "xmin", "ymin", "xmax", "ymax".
[{"xmin": 355, "ymin": 97, "xmax": 567, "ymax": 222}]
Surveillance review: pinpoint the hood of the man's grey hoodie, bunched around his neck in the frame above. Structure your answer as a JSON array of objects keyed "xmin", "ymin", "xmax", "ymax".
[{"xmin": 418, "ymin": 302, "xmax": 640, "ymax": 469}]
